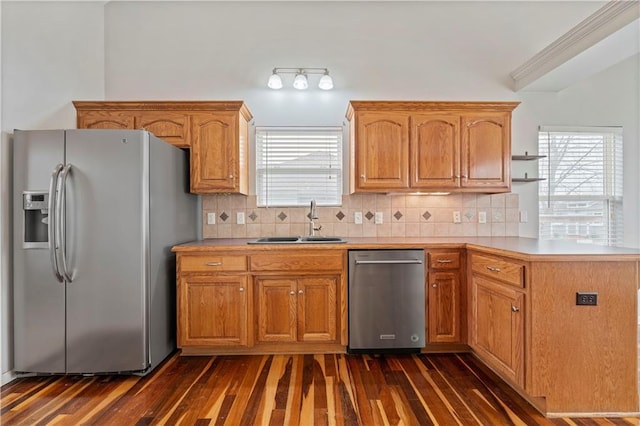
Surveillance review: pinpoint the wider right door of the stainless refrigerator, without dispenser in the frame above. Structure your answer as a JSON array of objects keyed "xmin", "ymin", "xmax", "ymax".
[{"xmin": 64, "ymin": 130, "xmax": 148, "ymax": 373}]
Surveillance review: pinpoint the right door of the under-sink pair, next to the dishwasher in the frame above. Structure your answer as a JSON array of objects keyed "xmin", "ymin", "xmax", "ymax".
[{"xmin": 298, "ymin": 277, "xmax": 338, "ymax": 342}]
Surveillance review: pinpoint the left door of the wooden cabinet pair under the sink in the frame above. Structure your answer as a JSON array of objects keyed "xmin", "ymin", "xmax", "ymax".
[{"xmin": 256, "ymin": 278, "xmax": 298, "ymax": 342}]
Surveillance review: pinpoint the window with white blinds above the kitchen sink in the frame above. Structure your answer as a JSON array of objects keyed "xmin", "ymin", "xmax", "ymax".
[{"xmin": 256, "ymin": 127, "xmax": 342, "ymax": 207}]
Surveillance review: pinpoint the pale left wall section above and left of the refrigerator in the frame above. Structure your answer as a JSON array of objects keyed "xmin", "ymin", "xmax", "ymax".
[{"xmin": 0, "ymin": 2, "xmax": 104, "ymax": 383}]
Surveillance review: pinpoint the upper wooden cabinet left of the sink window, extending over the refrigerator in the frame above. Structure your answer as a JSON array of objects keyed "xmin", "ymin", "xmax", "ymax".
[{"xmin": 73, "ymin": 101, "xmax": 252, "ymax": 194}]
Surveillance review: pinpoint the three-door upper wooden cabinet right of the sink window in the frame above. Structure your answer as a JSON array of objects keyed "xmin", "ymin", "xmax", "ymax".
[{"xmin": 347, "ymin": 101, "xmax": 518, "ymax": 193}]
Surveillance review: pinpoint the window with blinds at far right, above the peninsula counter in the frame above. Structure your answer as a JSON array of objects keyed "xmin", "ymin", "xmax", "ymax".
[{"xmin": 538, "ymin": 127, "xmax": 623, "ymax": 246}]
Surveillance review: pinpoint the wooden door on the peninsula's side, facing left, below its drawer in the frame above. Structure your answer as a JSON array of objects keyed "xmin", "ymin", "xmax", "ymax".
[{"xmin": 471, "ymin": 275, "xmax": 524, "ymax": 385}]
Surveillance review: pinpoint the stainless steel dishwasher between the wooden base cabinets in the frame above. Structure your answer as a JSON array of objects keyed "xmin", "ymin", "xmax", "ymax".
[{"xmin": 348, "ymin": 249, "xmax": 425, "ymax": 353}]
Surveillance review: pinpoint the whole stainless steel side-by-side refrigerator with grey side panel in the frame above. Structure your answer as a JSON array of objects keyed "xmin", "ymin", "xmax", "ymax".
[{"xmin": 13, "ymin": 130, "xmax": 199, "ymax": 374}]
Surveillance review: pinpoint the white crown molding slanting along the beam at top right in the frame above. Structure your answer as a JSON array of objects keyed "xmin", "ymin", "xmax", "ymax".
[{"xmin": 510, "ymin": 0, "xmax": 640, "ymax": 92}]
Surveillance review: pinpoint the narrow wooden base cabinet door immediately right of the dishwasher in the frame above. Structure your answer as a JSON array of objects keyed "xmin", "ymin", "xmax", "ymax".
[{"xmin": 428, "ymin": 271, "xmax": 460, "ymax": 343}]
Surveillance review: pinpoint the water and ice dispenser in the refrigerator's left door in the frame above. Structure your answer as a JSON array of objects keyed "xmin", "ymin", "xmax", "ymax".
[{"xmin": 22, "ymin": 191, "xmax": 49, "ymax": 249}]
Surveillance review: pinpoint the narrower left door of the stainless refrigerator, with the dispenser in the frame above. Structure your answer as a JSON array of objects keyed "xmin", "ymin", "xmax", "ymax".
[{"xmin": 13, "ymin": 130, "xmax": 65, "ymax": 373}]
